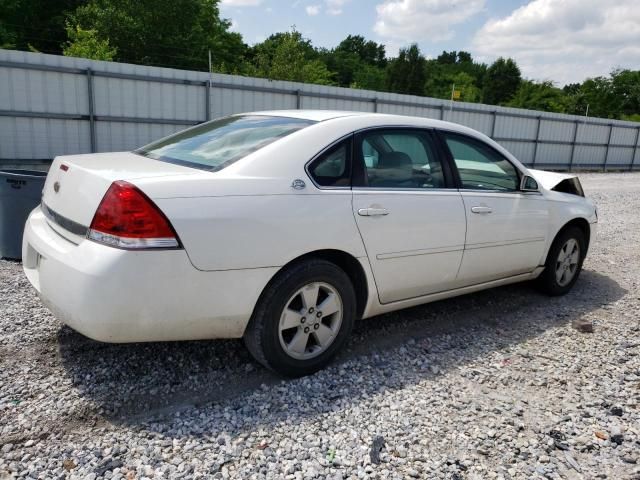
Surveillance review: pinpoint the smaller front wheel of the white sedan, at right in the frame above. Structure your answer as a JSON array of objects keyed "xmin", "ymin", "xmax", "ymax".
[{"xmin": 536, "ymin": 227, "xmax": 587, "ymax": 296}]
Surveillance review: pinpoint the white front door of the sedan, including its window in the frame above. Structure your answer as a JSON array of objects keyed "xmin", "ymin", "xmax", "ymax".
[{"xmin": 439, "ymin": 131, "xmax": 549, "ymax": 285}]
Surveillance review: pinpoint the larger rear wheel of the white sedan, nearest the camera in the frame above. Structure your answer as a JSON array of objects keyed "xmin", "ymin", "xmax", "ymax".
[{"xmin": 244, "ymin": 259, "xmax": 356, "ymax": 377}]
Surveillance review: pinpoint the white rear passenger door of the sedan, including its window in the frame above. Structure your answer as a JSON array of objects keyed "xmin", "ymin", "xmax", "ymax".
[{"xmin": 352, "ymin": 128, "xmax": 466, "ymax": 303}]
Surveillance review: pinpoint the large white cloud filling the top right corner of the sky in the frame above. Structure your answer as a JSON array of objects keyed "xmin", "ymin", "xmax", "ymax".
[{"xmin": 472, "ymin": 0, "xmax": 640, "ymax": 85}]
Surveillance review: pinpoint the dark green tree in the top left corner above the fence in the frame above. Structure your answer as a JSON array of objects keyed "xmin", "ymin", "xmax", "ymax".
[{"xmin": 0, "ymin": 0, "xmax": 87, "ymax": 54}]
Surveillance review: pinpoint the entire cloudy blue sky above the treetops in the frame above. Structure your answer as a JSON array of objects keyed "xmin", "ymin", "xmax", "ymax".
[{"xmin": 220, "ymin": 0, "xmax": 640, "ymax": 85}]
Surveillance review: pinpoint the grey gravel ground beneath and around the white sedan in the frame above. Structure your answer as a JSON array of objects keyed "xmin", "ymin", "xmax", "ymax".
[{"xmin": 0, "ymin": 174, "xmax": 640, "ymax": 480}]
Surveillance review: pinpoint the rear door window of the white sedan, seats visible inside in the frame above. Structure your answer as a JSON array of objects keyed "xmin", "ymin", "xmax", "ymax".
[{"xmin": 354, "ymin": 130, "xmax": 445, "ymax": 188}]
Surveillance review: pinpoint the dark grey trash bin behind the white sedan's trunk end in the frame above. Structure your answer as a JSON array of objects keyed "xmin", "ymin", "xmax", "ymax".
[{"xmin": 0, "ymin": 170, "xmax": 47, "ymax": 260}]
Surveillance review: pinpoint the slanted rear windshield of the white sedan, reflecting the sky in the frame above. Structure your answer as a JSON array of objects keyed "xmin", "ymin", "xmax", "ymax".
[{"xmin": 135, "ymin": 115, "xmax": 315, "ymax": 172}]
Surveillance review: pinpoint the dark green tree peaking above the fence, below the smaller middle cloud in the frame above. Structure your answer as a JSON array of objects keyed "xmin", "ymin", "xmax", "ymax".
[{"xmin": 387, "ymin": 43, "xmax": 426, "ymax": 95}]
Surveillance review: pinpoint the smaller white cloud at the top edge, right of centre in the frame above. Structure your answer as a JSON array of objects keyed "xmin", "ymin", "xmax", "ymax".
[{"xmin": 373, "ymin": 0, "xmax": 485, "ymax": 43}]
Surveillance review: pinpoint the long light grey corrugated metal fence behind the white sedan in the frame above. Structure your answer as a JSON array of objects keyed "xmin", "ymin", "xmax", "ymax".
[{"xmin": 0, "ymin": 50, "xmax": 640, "ymax": 170}]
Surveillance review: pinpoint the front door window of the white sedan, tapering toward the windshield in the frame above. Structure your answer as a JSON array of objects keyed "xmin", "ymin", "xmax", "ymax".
[{"xmin": 442, "ymin": 132, "xmax": 520, "ymax": 191}]
